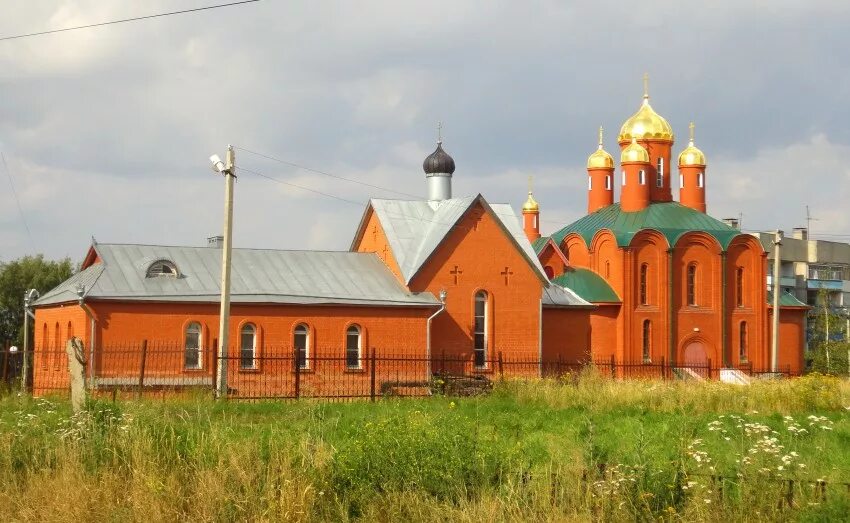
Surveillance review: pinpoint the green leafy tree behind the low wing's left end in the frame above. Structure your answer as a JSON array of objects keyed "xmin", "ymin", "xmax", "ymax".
[{"xmin": 0, "ymin": 254, "xmax": 73, "ymax": 345}]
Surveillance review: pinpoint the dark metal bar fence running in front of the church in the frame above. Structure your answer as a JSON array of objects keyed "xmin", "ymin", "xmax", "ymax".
[{"xmin": 0, "ymin": 341, "xmax": 790, "ymax": 400}]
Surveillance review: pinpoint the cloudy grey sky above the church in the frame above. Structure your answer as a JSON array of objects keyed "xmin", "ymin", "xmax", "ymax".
[{"xmin": 0, "ymin": 0, "xmax": 850, "ymax": 260}]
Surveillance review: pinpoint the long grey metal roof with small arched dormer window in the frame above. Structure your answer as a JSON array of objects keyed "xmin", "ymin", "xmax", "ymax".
[{"xmin": 35, "ymin": 244, "xmax": 439, "ymax": 306}]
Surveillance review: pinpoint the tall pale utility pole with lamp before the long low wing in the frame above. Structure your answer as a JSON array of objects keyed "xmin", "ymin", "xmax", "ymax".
[{"xmin": 210, "ymin": 145, "xmax": 236, "ymax": 398}]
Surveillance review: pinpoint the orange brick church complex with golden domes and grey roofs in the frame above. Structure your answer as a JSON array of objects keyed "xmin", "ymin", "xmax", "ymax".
[{"xmin": 33, "ymin": 81, "xmax": 806, "ymax": 390}]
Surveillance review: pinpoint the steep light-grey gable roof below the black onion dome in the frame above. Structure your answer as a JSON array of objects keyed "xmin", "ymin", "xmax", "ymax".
[{"xmin": 351, "ymin": 194, "xmax": 548, "ymax": 284}]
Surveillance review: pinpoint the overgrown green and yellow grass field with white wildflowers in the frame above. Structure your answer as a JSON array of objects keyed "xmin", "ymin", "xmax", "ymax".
[{"xmin": 0, "ymin": 372, "xmax": 850, "ymax": 522}]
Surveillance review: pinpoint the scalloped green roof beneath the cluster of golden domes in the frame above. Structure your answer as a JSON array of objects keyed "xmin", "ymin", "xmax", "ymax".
[{"xmin": 552, "ymin": 202, "xmax": 741, "ymax": 250}]
